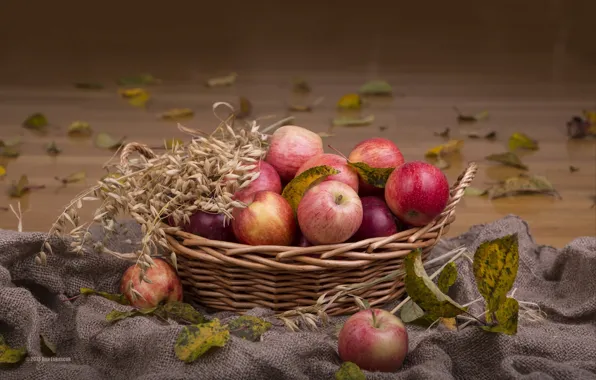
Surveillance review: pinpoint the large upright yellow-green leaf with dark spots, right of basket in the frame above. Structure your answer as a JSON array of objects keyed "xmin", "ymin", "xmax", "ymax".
[{"xmin": 472, "ymin": 233, "xmax": 519, "ymax": 323}]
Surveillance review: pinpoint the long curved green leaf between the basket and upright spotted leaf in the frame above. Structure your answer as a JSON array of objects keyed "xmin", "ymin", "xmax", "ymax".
[{"xmin": 404, "ymin": 249, "xmax": 467, "ymax": 318}]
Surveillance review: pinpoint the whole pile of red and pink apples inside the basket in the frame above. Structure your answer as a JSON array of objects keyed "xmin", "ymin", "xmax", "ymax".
[{"xmin": 170, "ymin": 125, "xmax": 449, "ymax": 246}]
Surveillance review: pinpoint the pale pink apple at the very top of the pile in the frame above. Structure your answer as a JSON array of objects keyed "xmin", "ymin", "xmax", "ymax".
[{"xmin": 265, "ymin": 125, "xmax": 323, "ymax": 183}]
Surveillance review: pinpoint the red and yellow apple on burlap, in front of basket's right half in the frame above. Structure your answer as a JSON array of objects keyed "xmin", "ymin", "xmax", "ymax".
[{"xmin": 338, "ymin": 308, "xmax": 408, "ymax": 372}]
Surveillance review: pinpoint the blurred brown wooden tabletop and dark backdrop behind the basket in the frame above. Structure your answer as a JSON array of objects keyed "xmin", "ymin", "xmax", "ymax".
[{"xmin": 0, "ymin": 0, "xmax": 596, "ymax": 246}]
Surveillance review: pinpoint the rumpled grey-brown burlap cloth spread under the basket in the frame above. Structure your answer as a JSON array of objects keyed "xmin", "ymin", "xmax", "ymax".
[{"xmin": 0, "ymin": 216, "xmax": 596, "ymax": 380}]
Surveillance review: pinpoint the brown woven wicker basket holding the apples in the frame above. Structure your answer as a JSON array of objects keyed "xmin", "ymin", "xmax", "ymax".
[{"xmin": 166, "ymin": 163, "xmax": 477, "ymax": 315}]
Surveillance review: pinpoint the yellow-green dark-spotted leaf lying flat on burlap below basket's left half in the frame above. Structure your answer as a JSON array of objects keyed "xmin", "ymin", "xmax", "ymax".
[{"xmin": 174, "ymin": 318, "xmax": 230, "ymax": 363}]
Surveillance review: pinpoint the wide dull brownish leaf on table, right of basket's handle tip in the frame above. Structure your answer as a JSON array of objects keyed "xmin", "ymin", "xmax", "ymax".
[{"xmin": 488, "ymin": 174, "xmax": 561, "ymax": 200}]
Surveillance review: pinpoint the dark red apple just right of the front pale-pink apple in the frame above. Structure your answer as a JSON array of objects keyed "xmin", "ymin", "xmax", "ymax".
[{"xmin": 352, "ymin": 196, "xmax": 397, "ymax": 241}]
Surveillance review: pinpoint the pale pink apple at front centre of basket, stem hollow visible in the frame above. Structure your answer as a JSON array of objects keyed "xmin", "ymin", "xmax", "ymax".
[{"xmin": 297, "ymin": 181, "xmax": 362, "ymax": 245}]
